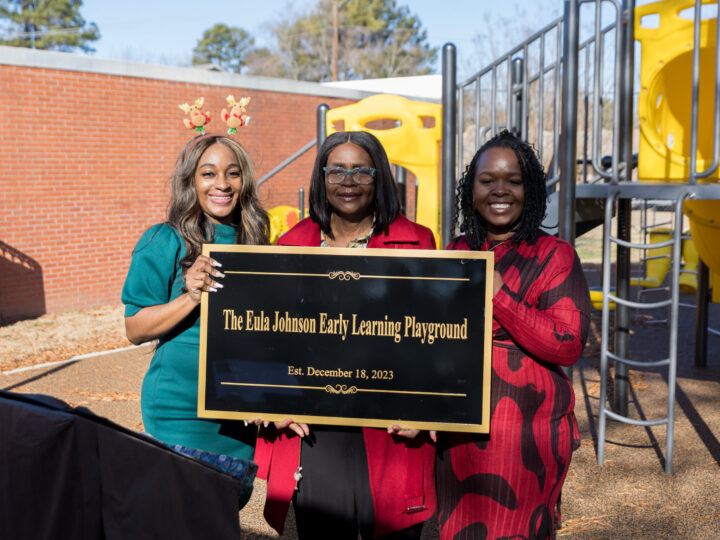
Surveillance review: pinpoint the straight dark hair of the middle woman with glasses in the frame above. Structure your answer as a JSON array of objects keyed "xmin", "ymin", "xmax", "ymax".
[{"xmin": 310, "ymin": 131, "xmax": 400, "ymax": 238}]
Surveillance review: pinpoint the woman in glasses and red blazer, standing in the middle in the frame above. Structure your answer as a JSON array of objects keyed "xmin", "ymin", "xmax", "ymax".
[{"xmin": 255, "ymin": 132, "xmax": 436, "ymax": 540}]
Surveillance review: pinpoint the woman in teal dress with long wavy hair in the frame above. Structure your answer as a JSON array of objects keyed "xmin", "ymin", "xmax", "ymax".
[{"xmin": 122, "ymin": 135, "xmax": 268, "ymax": 460}]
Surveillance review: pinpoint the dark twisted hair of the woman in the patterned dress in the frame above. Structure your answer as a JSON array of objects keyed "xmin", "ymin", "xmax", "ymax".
[{"xmin": 456, "ymin": 130, "xmax": 547, "ymax": 249}]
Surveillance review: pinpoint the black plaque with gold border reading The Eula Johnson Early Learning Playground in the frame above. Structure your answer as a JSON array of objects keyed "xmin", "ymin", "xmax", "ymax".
[{"xmin": 198, "ymin": 244, "xmax": 493, "ymax": 433}]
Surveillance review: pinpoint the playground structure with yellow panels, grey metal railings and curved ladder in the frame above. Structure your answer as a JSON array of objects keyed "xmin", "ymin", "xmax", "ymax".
[{"xmin": 261, "ymin": 0, "xmax": 720, "ymax": 474}]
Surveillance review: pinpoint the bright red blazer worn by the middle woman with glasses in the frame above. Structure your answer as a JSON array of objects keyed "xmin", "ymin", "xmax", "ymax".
[{"xmin": 255, "ymin": 215, "xmax": 437, "ymax": 537}]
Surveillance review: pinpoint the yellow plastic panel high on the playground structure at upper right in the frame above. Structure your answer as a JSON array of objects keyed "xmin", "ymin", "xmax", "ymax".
[{"xmin": 635, "ymin": 0, "xmax": 720, "ymax": 182}]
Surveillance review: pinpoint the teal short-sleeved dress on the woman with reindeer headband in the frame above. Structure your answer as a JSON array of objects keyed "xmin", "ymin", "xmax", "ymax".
[{"xmin": 122, "ymin": 224, "xmax": 257, "ymax": 460}]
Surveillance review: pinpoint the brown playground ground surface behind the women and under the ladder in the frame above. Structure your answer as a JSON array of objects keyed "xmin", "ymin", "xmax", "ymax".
[{"xmin": 0, "ymin": 268, "xmax": 720, "ymax": 540}]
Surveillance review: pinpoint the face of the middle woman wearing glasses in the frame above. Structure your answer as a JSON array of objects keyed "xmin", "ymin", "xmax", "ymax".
[{"xmin": 325, "ymin": 143, "xmax": 375, "ymax": 222}]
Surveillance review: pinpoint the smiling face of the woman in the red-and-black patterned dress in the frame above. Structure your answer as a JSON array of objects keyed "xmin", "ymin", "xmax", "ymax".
[{"xmin": 473, "ymin": 147, "xmax": 525, "ymax": 240}]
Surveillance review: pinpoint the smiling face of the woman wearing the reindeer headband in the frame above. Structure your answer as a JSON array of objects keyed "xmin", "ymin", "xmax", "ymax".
[{"xmin": 194, "ymin": 143, "xmax": 242, "ymax": 225}]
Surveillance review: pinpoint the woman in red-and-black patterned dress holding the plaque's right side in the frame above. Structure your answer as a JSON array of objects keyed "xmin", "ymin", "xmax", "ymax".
[{"xmin": 436, "ymin": 131, "xmax": 590, "ymax": 540}]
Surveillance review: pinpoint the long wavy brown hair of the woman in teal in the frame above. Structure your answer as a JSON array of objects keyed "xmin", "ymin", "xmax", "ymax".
[{"xmin": 168, "ymin": 135, "xmax": 270, "ymax": 273}]
